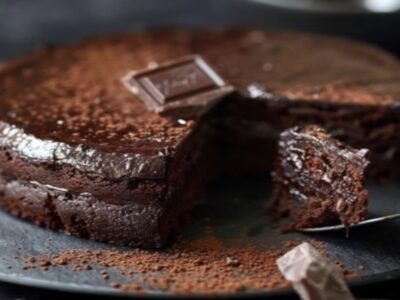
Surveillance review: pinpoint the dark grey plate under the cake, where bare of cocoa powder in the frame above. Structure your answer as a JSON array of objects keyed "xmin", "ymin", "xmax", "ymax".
[{"xmin": 0, "ymin": 178, "xmax": 400, "ymax": 297}]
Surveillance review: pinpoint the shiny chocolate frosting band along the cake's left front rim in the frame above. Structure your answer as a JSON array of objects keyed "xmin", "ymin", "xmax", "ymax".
[{"xmin": 0, "ymin": 122, "xmax": 168, "ymax": 179}]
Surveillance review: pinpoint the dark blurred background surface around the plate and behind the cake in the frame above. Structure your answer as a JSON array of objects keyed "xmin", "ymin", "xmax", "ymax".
[{"xmin": 0, "ymin": 0, "xmax": 400, "ymax": 300}]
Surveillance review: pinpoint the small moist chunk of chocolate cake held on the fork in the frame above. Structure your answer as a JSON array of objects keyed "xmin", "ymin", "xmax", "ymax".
[{"xmin": 272, "ymin": 125, "xmax": 369, "ymax": 229}]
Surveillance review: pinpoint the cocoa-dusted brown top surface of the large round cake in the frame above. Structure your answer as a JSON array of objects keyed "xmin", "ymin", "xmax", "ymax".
[{"xmin": 0, "ymin": 30, "xmax": 400, "ymax": 153}]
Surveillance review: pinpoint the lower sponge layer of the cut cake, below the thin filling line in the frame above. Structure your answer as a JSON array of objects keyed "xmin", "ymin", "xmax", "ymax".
[{"xmin": 0, "ymin": 171, "xmax": 201, "ymax": 248}]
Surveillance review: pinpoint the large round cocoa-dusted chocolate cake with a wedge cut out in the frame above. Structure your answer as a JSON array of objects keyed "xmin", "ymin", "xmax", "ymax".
[{"xmin": 0, "ymin": 30, "xmax": 400, "ymax": 247}]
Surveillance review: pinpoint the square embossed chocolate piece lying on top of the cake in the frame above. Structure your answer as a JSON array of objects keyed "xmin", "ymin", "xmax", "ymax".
[{"xmin": 122, "ymin": 55, "xmax": 233, "ymax": 117}]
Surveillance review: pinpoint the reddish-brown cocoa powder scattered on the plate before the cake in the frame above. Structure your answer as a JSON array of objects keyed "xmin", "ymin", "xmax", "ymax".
[{"xmin": 21, "ymin": 236, "xmax": 354, "ymax": 294}]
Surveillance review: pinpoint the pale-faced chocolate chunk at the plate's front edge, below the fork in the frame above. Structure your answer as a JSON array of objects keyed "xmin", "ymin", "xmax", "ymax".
[{"xmin": 277, "ymin": 243, "xmax": 354, "ymax": 300}]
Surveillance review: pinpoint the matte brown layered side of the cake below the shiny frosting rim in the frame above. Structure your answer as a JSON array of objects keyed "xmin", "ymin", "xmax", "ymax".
[{"xmin": 0, "ymin": 114, "xmax": 213, "ymax": 248}]
